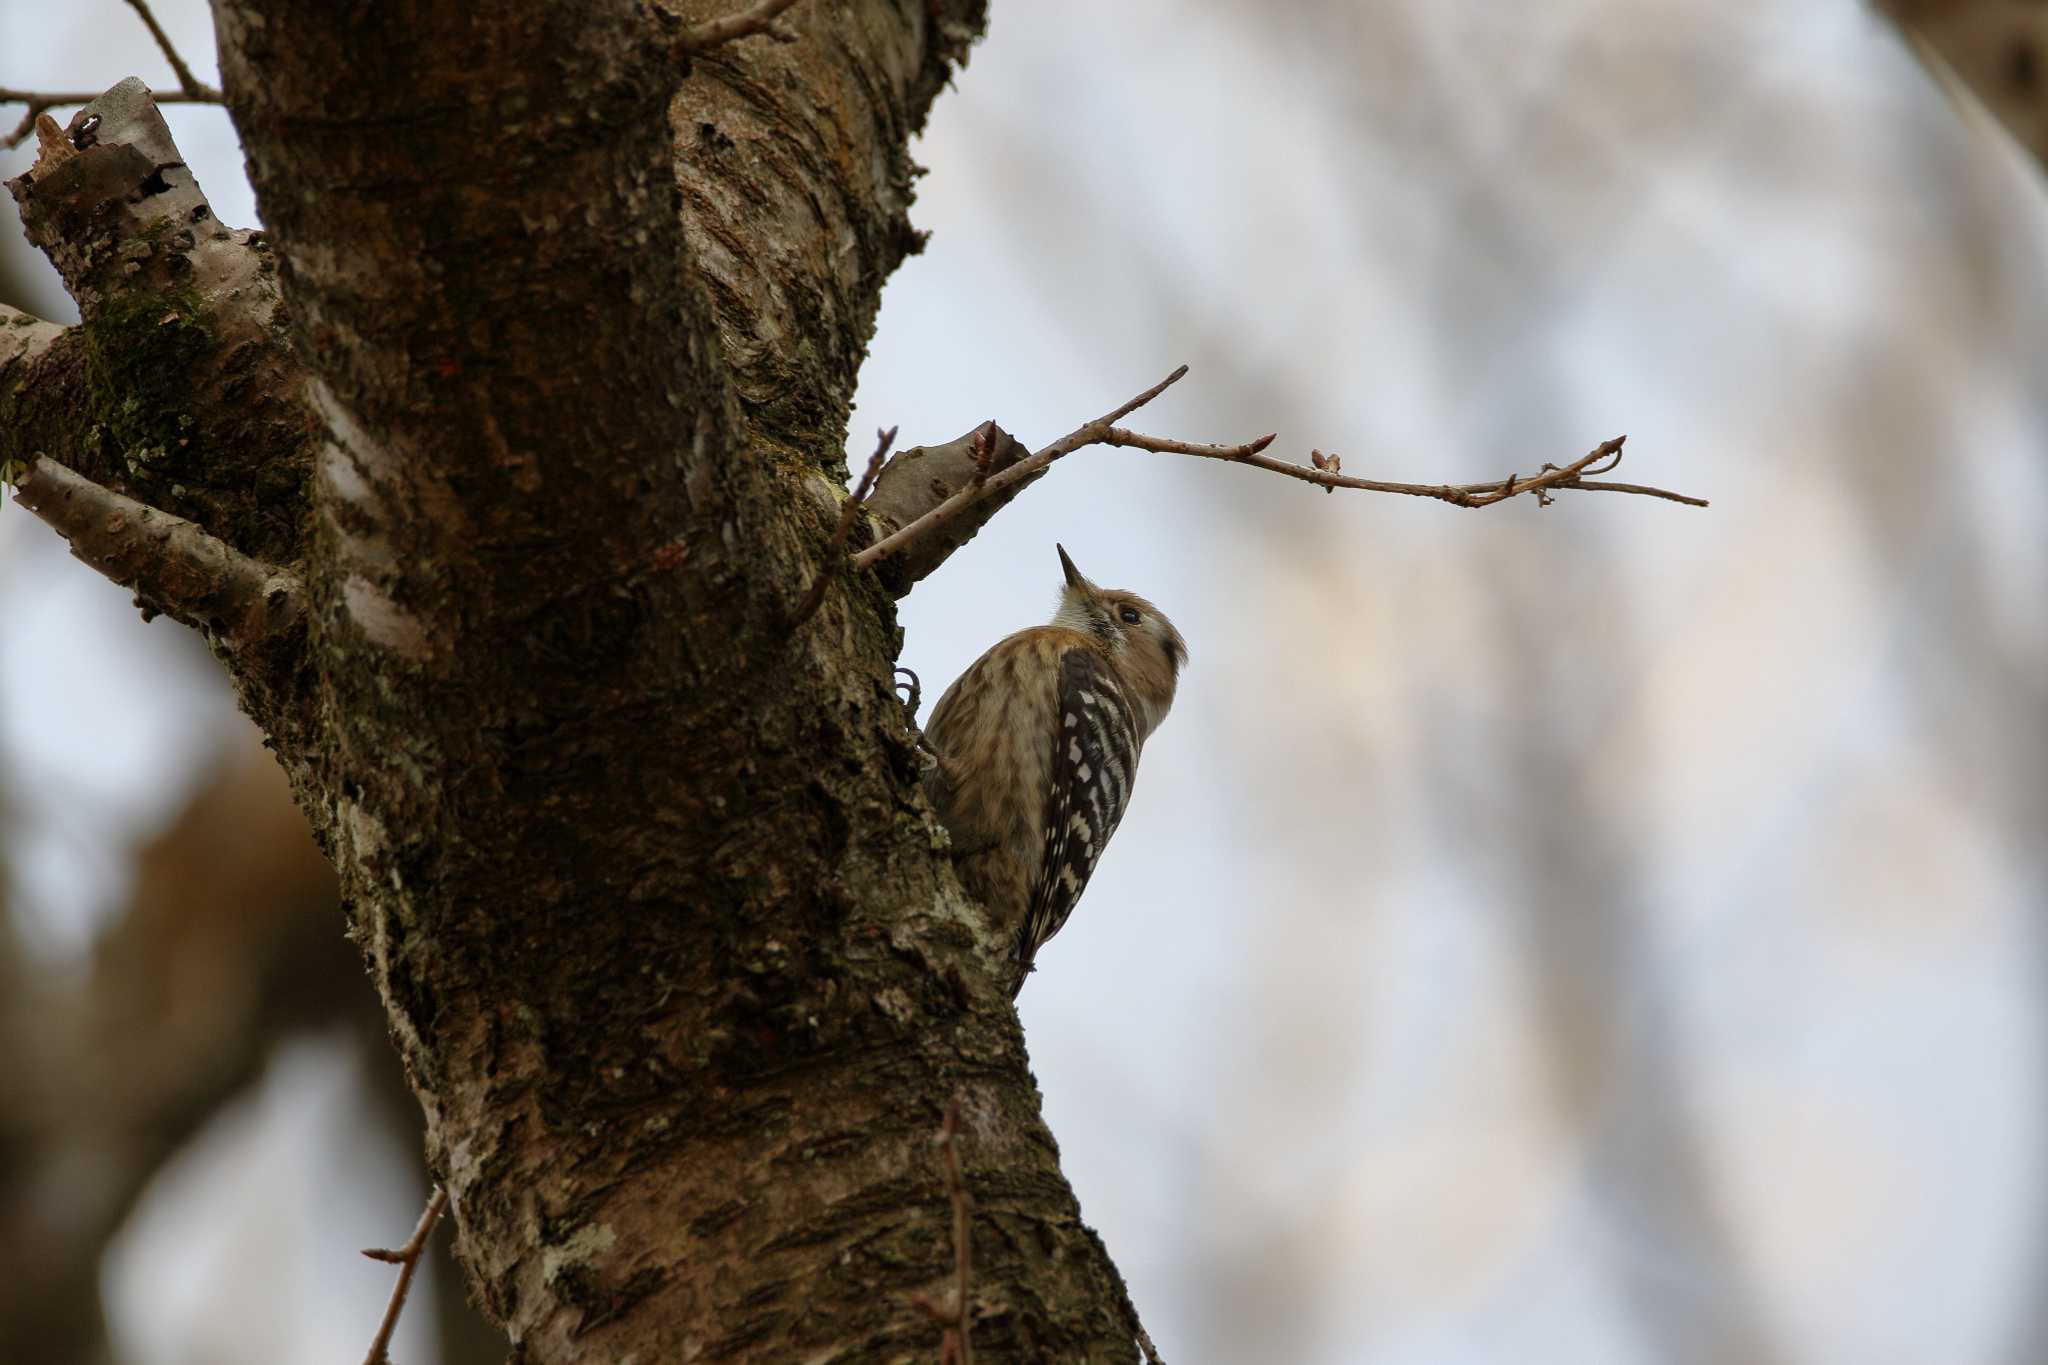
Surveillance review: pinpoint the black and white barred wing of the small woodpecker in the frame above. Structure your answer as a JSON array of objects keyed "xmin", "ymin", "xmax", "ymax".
[{"xmin": 1018, "ymin": 649, "xmax": 1139, "ymax": 980}]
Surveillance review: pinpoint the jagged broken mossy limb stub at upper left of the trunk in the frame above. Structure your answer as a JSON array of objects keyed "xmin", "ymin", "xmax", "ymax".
[{"xmin": 0, "ymin": 80, "xmax": 313, "ymax": 563}]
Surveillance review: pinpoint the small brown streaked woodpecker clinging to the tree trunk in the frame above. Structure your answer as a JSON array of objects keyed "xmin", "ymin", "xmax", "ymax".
[{"xmin": 926, "ymin": 548, "xmax": 1188, "ymax": 990}]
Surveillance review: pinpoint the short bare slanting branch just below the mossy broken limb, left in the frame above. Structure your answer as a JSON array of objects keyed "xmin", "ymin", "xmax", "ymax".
[{"xmin": 14, "ymin": 456, "xmax": 305, "ymax": 653}]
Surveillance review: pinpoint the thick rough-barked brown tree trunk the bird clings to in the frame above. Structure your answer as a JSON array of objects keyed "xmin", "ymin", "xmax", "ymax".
[{"xmin": 0, "ymin": 0, "xmax": 1163, "ymax": 1363}]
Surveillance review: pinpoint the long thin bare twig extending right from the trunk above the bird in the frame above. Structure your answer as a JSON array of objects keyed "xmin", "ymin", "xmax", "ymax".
[{"xmin": 854, "ymin": 364, "xmax": 1706, "ymax": 569}]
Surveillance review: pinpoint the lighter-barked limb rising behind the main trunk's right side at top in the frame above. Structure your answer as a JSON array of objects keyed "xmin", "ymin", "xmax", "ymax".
[{"xmin": 670, "ymin": 0, "xmax": 983, "ymax": 473}]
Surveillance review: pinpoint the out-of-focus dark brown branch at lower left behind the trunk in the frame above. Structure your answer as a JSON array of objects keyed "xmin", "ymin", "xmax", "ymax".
[{"xmin": 0, "ymin": 731, "xmax": 504, "ymax": 1365}]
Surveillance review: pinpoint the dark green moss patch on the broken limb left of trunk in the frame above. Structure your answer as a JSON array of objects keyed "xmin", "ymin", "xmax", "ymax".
[{"xmin": 84, "ymin": 289, "xmax": 213, "ymax": 475}]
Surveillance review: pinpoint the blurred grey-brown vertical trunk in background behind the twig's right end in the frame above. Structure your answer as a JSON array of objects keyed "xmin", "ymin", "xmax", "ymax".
[{"xmin": 1362, "ymin": 7, "xmax": 1790, "ymax": 1342}]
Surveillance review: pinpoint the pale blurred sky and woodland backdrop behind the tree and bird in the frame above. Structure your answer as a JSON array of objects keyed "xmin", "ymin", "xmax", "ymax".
[{"xmin": 0, "ymin": 0, "xmax": 2048, "ymax": 1365}]
